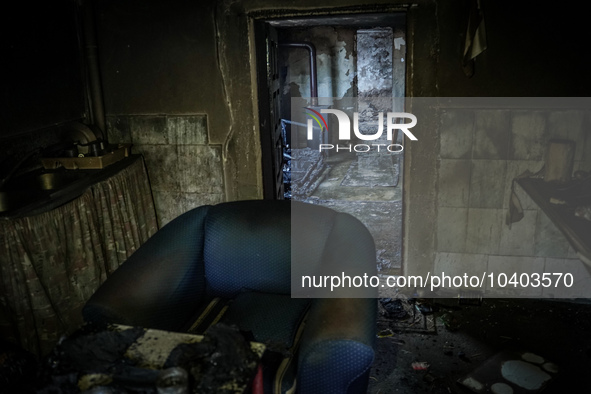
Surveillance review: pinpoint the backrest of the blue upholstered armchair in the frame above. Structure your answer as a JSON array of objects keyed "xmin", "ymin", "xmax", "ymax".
[{"xmin": 203, "ymin": 200, "xmax": 375, "ymax": 298}]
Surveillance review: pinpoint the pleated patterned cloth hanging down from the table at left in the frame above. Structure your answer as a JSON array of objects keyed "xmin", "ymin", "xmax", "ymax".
[{"xmin": 0, "ymin": 155, "xmax": 158, "ymax": 356}]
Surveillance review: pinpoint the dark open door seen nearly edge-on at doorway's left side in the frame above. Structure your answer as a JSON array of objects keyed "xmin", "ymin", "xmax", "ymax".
[{"xmin": 255, "ymin": 21, "xmax": 284, "ymax": 200}]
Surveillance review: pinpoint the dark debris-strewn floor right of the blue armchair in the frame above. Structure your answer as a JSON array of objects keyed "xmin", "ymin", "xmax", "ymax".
[{"xmin": 368, "ymin": 299, "xmax": 591, "ymax": 394}]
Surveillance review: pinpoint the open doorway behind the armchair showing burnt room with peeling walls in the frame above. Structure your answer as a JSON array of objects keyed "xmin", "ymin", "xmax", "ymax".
[{"xmin": 255, "ymin": 13, "xmax": 406, "ymax": 275}]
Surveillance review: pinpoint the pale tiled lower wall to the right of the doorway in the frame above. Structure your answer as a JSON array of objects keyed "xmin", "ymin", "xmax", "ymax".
[{"xmin": 435, "ymin": 108, "xmax": 591, "ymax": 295}]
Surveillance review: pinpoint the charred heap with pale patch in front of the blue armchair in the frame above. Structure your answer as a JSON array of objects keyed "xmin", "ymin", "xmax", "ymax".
[{"xmin": 31, "ymin": 324, "xmax": 259, "ymax": 394}]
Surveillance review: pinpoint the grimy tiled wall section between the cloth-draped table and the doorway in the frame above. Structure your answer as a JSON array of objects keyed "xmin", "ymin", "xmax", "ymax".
[{"xmin": 107, "ymin": 115, "xmax": 225, "ymax": 226}]
